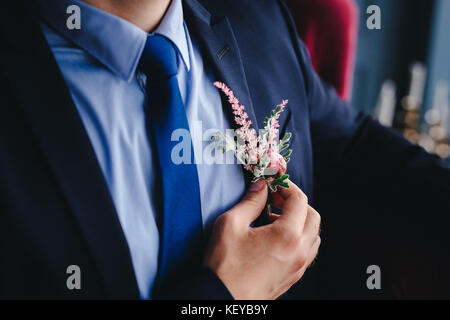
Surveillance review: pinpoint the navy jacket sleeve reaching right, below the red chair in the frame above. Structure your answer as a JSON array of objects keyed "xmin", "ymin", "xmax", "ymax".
[{"xmin": 283, "ymin": 0, "xmax": 450, "ymax": 236}]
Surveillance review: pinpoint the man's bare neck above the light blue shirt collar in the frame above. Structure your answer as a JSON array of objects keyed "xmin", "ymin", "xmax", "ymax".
[{"xmin": 83, "ymin": 0, "xmax": 172, "ymax": 32}]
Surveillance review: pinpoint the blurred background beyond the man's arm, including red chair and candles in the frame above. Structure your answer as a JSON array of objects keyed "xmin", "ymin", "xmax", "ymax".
[{"xmin": 286, "ymin": 0, "xmax": 450, "ymax": 165}]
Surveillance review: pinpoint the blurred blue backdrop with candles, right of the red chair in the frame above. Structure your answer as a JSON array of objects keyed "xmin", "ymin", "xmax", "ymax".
[{"xmin": 351, "ymin": 0, "xmax": 450, "ymax": 164}]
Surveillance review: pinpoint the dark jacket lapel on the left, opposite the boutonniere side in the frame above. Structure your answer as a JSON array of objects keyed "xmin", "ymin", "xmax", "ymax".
[{"xmin": 0, "ymin": 1, "xmax": 139, "ymax": 298}]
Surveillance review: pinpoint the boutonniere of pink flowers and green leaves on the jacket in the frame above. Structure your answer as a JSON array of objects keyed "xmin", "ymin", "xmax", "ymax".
[{"xmin": 214, "ymin": 82, "xmax": 292, "ymax": 226}]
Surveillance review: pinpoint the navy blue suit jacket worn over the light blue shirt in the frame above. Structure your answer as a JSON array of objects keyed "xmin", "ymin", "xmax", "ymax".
[{"xmin": 0, "ymin": 0, "xmax": 450, "ymax": 299}]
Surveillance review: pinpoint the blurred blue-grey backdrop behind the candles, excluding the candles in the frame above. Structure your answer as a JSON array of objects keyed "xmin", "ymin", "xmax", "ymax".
[{"xmin": 352, "ymin": 0, "xmax": 450, "ymax": 165}]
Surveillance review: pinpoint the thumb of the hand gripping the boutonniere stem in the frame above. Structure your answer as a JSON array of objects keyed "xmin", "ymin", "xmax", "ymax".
[{"xmin": 230, "ymin": 180, "xmax": 267, "ymax": 224}]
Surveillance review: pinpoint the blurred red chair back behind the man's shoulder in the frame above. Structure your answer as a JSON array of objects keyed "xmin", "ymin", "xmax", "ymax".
[{"xmin": 285, "ymin": 0, "xmax": 359, "ymax": 100}]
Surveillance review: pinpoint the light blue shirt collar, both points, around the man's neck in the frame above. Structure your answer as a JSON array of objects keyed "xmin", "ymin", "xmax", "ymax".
[{"xmin": 39, "ymin": 0, "xmax": 190, "ymax": 81}]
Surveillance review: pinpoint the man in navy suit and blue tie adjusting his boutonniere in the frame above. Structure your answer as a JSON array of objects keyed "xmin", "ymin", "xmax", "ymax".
[{"xmin": 0, "ymin": 0, "xmax": 449, "ymax": 299}]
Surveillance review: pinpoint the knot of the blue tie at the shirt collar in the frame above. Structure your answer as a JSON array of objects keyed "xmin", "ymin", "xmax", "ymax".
[{"xmin": 139, "ymin": 35, "xmax": 178, "ymax": 80}]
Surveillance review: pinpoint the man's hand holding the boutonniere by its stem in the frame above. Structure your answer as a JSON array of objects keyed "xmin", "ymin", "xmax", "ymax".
[{"xmin": 205, "ymin": 181, "xmax": 320, "ymax": 300}]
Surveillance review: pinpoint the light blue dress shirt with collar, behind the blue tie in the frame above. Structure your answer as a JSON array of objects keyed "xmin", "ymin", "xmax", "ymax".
[{"xmin": 40, "ymin": 0, "xmax": 244, "ymax": 299}]
